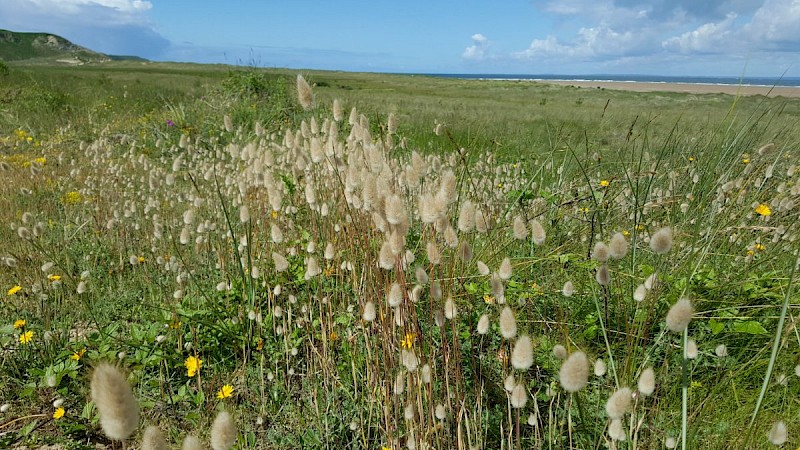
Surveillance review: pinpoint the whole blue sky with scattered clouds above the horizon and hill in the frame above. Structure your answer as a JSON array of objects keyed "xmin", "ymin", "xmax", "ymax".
[{"xmin": 0, "ymin": 0, "xmax": 800, "ymax": 76}]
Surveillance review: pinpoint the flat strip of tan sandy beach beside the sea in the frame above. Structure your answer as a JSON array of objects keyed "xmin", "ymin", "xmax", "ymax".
[{"xmin": 537, "ymin": 80, "xmax": 800, "ymax": 97}]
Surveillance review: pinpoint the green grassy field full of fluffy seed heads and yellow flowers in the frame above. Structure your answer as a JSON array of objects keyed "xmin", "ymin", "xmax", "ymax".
[{"xmin": 0, "ymin": 61, "xmax": 800, "ymax": 450}]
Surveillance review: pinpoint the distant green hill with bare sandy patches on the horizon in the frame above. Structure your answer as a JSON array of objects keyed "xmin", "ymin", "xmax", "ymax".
[{"xmin": 0, "ymin": 29, "xmax": 143, "ymax": 64}]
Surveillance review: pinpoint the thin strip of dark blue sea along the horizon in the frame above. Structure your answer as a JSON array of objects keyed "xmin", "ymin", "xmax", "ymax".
[{"xmin": 420, "ymin": 73, "xmax": 800, "ymax": 87}]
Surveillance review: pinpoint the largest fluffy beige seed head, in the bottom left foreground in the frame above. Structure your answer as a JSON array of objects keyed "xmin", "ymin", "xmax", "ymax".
[{"xmin": 90, "ymin": 363, "xmax": 139, "ymax": 441}]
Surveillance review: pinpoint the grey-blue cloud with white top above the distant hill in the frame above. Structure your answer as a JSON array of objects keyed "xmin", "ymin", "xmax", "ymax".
[{"xmin": 0, "ymin": 0, "xmax": 170, "ymax": 59}]
